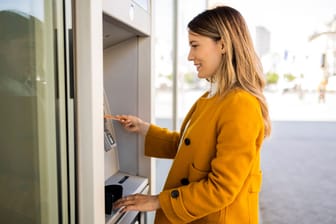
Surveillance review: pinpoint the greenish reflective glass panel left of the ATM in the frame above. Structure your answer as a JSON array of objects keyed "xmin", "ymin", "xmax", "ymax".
[{"xmin": 0, "ymin": 0, "xmax": 58, "ymax": 224}]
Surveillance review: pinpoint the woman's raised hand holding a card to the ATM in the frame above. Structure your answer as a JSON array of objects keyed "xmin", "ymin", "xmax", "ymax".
[{"xmin": 116, "ymin": 115, "xmax": 149, "ymax": 135}]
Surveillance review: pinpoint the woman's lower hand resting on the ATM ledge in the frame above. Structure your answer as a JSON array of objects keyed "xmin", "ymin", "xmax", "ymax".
[{"xmin": 113, "ymin": 194, "xmax": 161, "ymax": 212}]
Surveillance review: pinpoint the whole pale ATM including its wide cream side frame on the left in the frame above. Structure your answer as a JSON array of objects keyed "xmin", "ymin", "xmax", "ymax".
[{"xmin": 74, "ymin": 0, "xmax": 154, "ymax": 224}]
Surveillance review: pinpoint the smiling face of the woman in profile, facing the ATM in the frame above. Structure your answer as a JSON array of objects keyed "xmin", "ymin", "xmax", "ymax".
[{"xmin": 188, "ymin": 31, "xmax": 224, "ymax": 78}]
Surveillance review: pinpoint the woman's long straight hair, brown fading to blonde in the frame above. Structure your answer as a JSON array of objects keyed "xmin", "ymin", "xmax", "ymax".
[{"xmin": 188, "ymin": 6, "xmax": 271, "ymax": 136}]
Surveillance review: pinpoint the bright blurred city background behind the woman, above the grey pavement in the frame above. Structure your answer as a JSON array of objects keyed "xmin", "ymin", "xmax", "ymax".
[{"xmin": 153, "ymin": 0, "xmax": 336, "ymax": 122}]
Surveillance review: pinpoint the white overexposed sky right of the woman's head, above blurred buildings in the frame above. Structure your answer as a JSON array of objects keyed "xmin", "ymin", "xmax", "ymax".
[{"xmin": 209, "ymin": 0, "xmax": 336, "ymax": 50}]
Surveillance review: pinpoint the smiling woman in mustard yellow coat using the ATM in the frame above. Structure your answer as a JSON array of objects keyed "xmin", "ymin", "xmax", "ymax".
[{"xmin": 114, "ymin": 6, "xmax": 271, "ymax": 224}]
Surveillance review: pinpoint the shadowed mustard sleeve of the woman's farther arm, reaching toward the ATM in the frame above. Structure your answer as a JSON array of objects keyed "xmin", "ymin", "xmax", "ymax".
[{"xmin": 145, "ymin": 125, "xmax": 180, "ymax": 159}]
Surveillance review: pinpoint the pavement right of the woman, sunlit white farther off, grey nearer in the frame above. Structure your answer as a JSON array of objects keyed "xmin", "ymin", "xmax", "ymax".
[{"xmin": 260, "ymin": 93, "xmax": 336, "ymax": 224}]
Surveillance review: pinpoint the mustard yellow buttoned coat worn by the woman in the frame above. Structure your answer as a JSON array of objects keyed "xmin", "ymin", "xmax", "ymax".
[{"xmin": 145, "ymin": 90, "xmax": 264, "ymax": 224}]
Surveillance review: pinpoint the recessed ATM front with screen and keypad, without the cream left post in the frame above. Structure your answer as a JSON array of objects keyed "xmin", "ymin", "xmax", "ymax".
[{"xmin": 102, "ymin": 0, "xmax": 151, "ymax": 224}]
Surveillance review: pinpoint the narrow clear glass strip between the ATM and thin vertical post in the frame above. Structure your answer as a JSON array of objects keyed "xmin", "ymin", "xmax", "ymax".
[{"xmin": 153, "ymin": 0, "xmax": 174, "ymax": 214}]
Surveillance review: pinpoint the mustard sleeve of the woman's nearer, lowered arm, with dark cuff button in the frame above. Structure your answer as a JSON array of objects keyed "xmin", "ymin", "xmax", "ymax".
[{"xmin": 159, "ymin": 93, "xmax": 263, "ymax": 223}]
